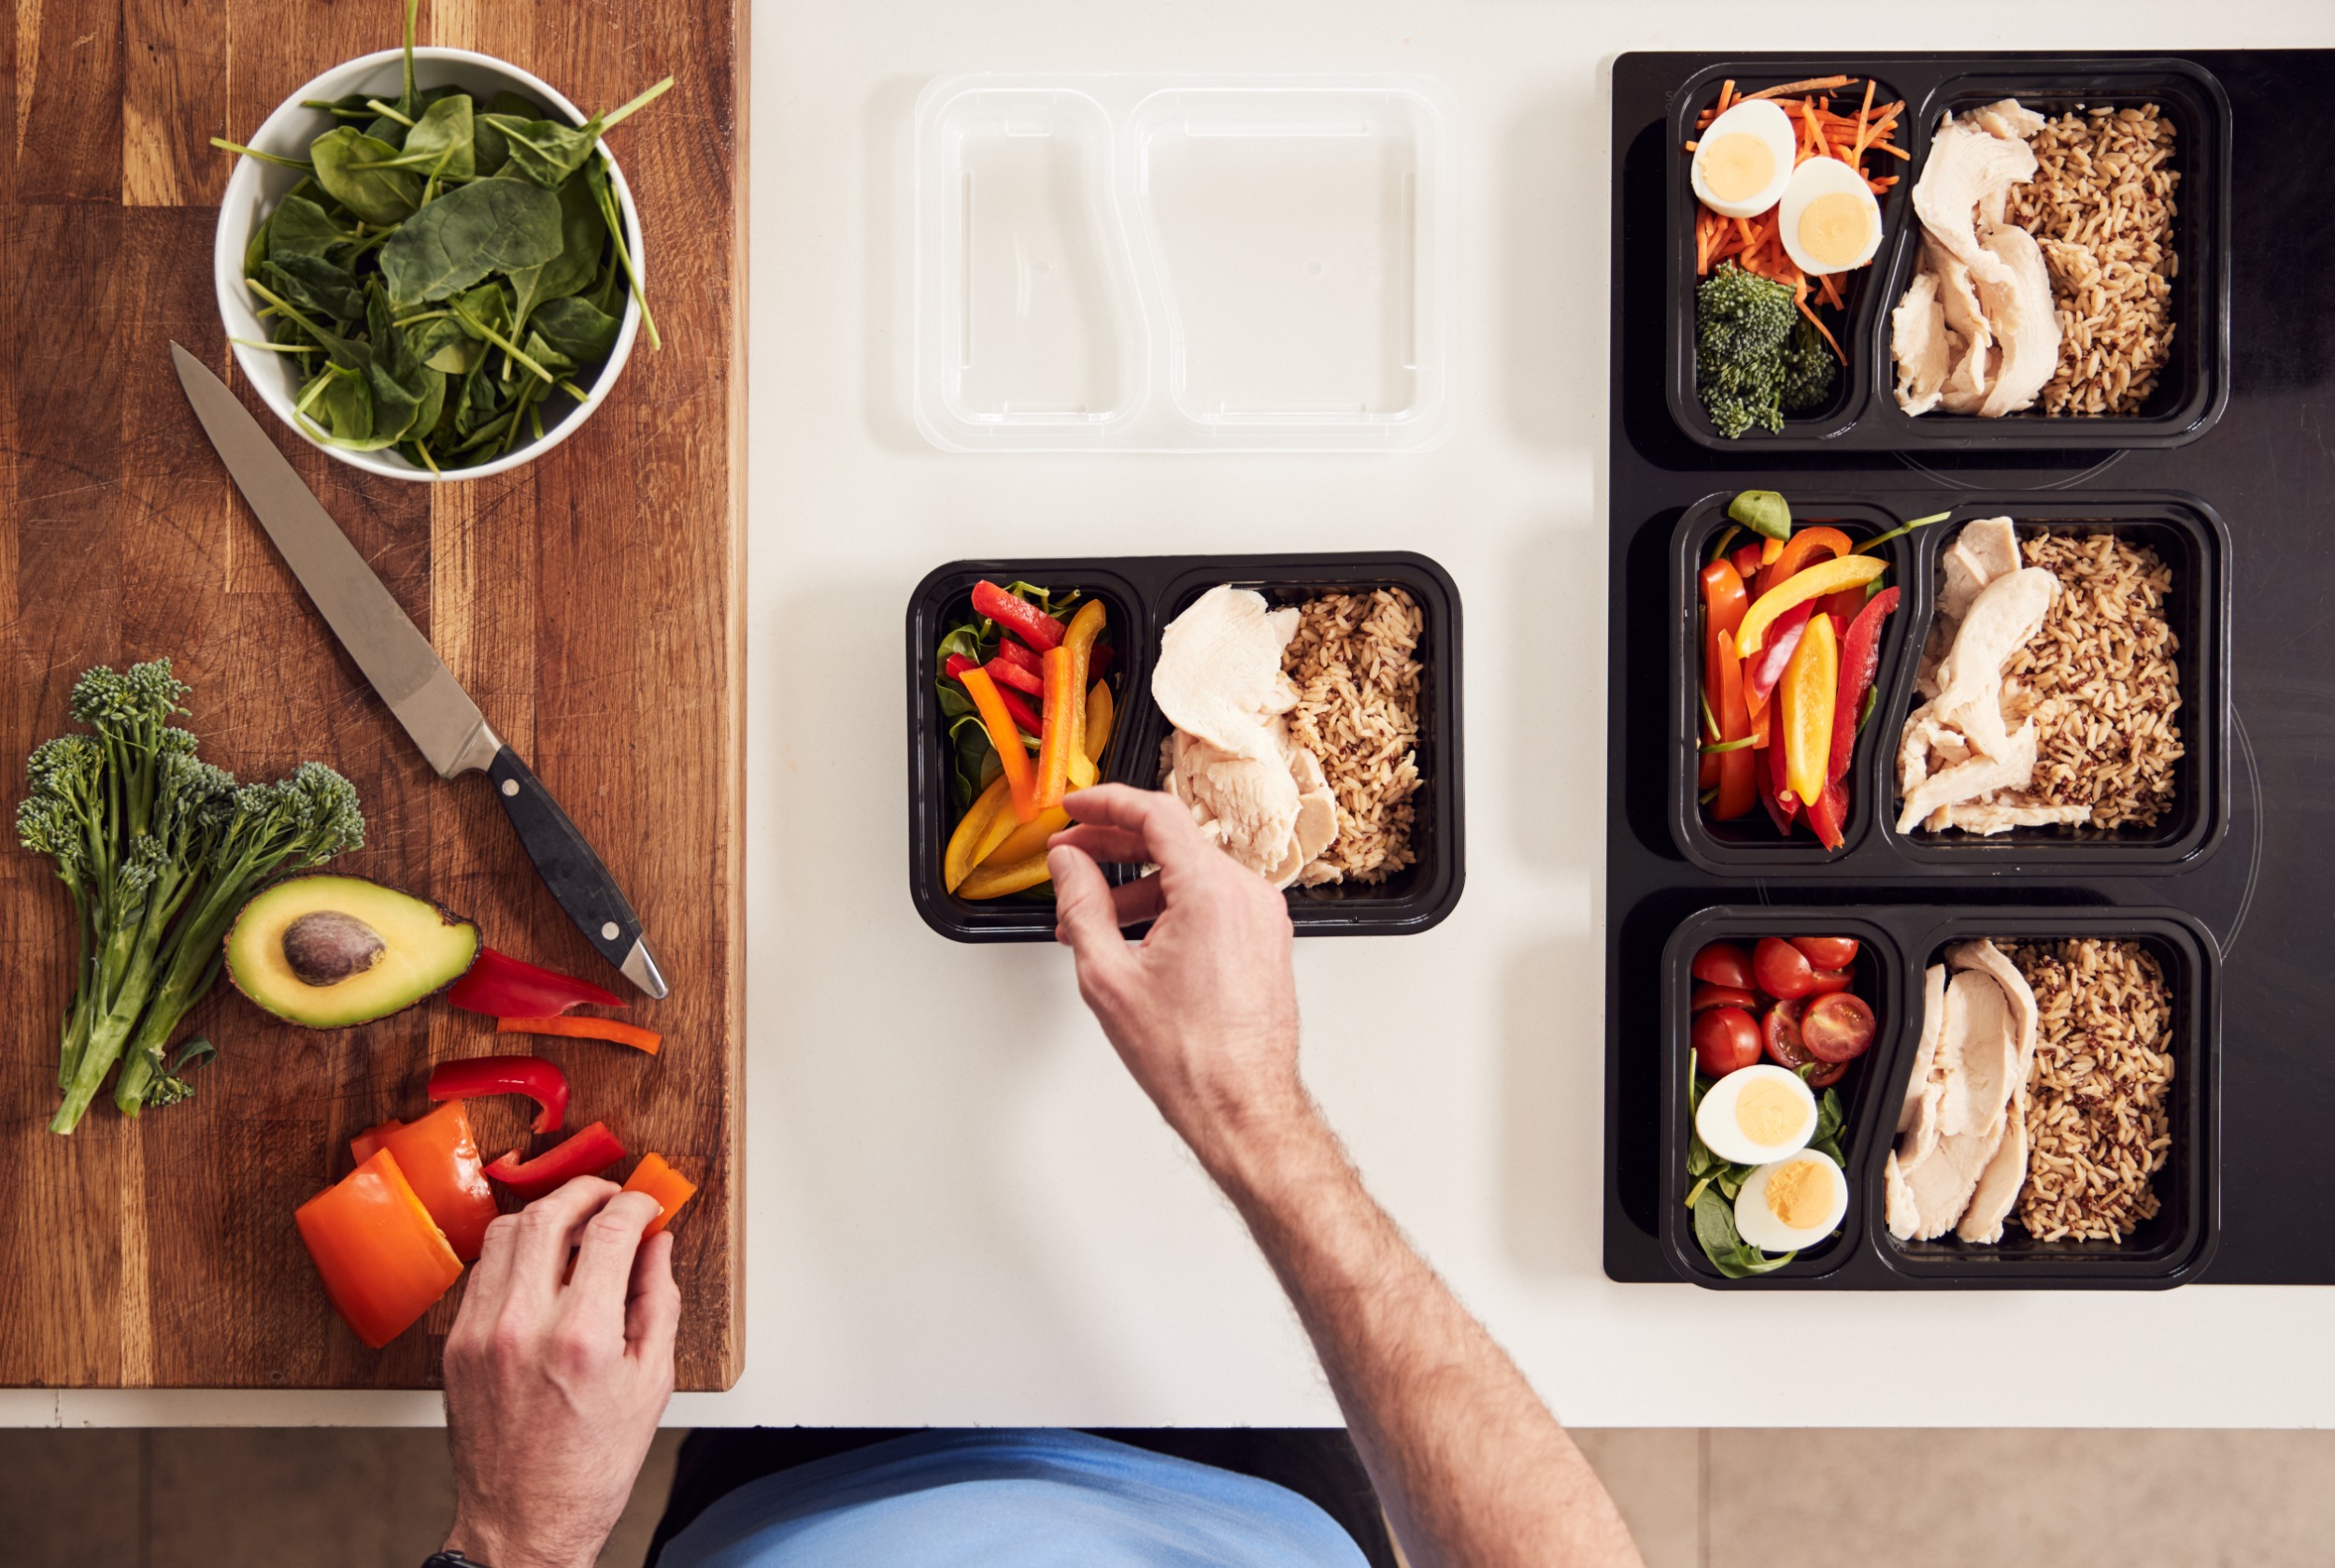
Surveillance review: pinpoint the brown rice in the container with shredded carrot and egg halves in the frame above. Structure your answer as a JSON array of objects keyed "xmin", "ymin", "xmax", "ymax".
[{"xmin": 2008, "ymin": 103, "xmax": 2181, "ymax": 414}]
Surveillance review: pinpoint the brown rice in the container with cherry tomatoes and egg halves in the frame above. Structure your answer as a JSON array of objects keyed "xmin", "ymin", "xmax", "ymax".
[{"xmin": 2003, "ymin": 939, "xmax": 2174, "ymax": 1241}]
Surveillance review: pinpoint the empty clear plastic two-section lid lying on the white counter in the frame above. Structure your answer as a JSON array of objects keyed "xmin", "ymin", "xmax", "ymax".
[{"xmin": 916, "ymin": 75, "xmax": 1457, "ymax": 451}]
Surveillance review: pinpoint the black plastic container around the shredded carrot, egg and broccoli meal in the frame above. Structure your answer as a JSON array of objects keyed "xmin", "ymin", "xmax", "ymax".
[{"xmin": 1665, "ymin": 54, "xmax": 2232, "ymax": 458}]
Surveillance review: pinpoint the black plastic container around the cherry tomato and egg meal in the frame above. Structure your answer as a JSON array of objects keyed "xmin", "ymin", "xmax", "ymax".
[{"xmin": 1660, "ymin": 905, "xmax": 2221, "ymax": 1290}]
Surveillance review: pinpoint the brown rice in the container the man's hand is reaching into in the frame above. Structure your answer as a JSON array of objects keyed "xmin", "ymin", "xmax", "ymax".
[{"xmin": 1282, "ymin": 589, "xmax": 1424, "ymax": 883}]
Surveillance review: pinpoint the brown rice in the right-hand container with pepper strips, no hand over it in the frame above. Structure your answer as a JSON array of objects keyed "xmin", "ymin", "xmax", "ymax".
[{"xmin": 2003, "ymin": 531, "xmax": 2186, "ymax": 827}]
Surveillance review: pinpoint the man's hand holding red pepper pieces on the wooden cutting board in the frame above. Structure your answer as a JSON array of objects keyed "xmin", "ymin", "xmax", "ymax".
[{"xmin": 446, "ymin": 1176, "xmax": 682, "ymax": 1568}]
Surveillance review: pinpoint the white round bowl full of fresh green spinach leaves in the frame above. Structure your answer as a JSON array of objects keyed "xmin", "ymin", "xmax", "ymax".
[{"xmin": 212, "ymin": 7, "xmax": 673, "ymax": 481}]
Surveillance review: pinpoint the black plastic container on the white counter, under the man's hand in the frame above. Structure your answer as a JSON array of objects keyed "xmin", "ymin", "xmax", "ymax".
[{"xmin": 908, "ymin": 551, "xmax": 1466, "ymax": 942}]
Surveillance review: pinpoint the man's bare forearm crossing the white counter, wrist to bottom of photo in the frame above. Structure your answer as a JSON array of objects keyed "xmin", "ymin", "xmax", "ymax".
[{"xmin": 1209, "ymin": 1105, "xmax": 1639, "ymax": 1568}]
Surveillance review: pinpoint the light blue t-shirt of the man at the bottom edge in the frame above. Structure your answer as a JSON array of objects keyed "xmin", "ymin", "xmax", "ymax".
[{"xmin": 661, "ymin": 1430, "xmax": 1366, "ymax": 1568}]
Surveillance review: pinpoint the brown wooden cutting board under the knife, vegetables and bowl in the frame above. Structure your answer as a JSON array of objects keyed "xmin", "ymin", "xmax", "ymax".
[{"xmin": 0, "ymin": 0, "xmax": 745, "ymax": 1388}]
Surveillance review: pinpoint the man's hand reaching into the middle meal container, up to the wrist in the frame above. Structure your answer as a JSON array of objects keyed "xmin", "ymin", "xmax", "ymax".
[{"xmin": 1046, "ymin": 785, "xmax": 1315, "ymax": 1180}]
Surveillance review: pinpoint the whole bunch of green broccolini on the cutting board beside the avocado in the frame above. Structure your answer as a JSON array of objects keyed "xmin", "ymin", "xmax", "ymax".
[{"xmin": 16, "ymin": 659, "xmax": 364, "ymax": 1133}]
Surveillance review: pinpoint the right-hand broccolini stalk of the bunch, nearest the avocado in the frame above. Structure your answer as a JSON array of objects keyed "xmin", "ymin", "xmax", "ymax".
[{"xmin": 114, "ymin": 762, "xmax": 364, "ymax": 1117}]
